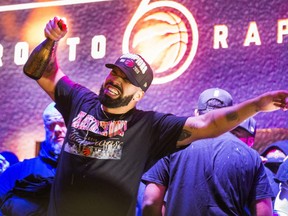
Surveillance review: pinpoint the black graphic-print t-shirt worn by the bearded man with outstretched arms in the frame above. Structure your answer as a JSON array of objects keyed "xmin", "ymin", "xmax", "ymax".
[{"xmin": 49, "ymin": 77, "xmax": 187, "ymax": 216}]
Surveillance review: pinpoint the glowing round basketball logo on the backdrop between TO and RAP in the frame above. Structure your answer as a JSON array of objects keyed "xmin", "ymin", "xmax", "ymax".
[{"xmin": 122, "ymin": 0, "xmax": 198, "ymax": 84}]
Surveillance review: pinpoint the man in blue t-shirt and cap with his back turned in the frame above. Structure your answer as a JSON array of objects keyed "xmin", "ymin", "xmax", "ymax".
[{"xmin": 142, "ymin": 88, "xmax": 273, "ymax": 216}]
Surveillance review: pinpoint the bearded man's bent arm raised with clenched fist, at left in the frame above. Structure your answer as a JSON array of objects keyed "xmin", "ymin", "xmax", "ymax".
[{"xmin": 23, "ymin": 17, "xmax": 68, "ymax": 100}]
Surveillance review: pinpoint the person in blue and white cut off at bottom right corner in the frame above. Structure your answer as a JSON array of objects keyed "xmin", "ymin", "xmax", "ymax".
[{"xmin": 274, "ymin": 155, "xmax": 288, "ymax": 216}]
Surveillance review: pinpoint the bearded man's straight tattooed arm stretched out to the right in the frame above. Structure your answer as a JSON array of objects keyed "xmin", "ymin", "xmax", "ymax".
[{"xmin": 177, "ymin": 90, "xmax": 288, "ymax": 147}]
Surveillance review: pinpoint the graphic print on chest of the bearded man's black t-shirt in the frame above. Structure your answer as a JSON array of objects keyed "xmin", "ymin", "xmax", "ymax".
[{"xmin": 64, "ymin": 111, "xmax": 127, "ymax": 160}]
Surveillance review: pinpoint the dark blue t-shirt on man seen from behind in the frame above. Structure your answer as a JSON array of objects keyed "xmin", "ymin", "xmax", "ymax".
[{"xmin": 142, "ymin": 133, "xmax": 273, "ymax": 216}]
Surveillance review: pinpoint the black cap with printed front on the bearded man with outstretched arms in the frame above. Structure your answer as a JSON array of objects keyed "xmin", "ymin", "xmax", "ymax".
[{"xmin": 105, "ymin": 53, "xmax": 153, "ymax": 92}]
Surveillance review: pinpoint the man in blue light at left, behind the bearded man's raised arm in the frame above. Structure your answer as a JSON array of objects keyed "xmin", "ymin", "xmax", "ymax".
[{"xmin": 0, "ymin": 102, "xmax": 67, "ymax": 216}]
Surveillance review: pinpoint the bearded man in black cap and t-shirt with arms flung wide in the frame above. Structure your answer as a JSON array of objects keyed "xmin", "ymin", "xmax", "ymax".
[{"xmin": 23, "ymin": 17, "xmax": 288, "ymax": 216}]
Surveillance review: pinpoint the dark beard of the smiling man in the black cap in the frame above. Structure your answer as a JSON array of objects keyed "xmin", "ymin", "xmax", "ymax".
[{"xmin": 99, "ymin": 85, "xmax": 133, "ymax": 108}]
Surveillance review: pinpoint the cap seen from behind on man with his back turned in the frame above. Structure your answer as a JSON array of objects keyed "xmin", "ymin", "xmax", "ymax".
[{"xmin": 198, "ymin": 88, "xmax": 233, "ymax": 110}]
